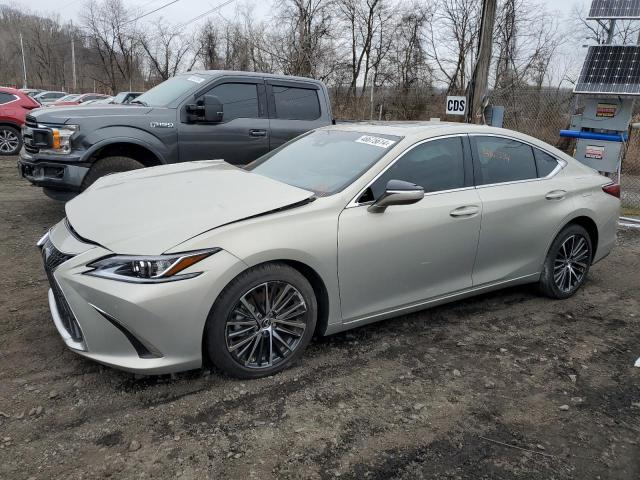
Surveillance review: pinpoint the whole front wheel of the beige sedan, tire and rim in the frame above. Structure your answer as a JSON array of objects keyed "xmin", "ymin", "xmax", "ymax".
[{"xmin": 205, "ymin": 263, "xmax": 318, "ymax": 378}]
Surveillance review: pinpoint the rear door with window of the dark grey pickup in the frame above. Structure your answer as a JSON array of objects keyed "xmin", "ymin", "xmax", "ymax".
[{"xmin": 266, "ymin": 79, "xmax": 329, "ymax": 150}]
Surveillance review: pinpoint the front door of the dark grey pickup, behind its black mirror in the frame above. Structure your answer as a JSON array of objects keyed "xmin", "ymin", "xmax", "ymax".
[{"xmin": 178, "ymin": 77, "xmax": 269, "ymax": 165}]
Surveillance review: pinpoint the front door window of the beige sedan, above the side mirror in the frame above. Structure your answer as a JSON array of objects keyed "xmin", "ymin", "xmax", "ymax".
[{"xmin": 370, "ymin": 137, "xmax": 464, "ymax": 200}]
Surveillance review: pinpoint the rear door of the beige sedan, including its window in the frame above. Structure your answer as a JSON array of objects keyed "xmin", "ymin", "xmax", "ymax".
[{"xmin": 470, "ymin": 135, "xmax": 573, "ymax": 285}]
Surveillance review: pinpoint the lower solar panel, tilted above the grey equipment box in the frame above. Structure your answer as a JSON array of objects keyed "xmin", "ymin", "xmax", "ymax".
[{"xmin": 573, "ymin": 45, "xmax": 640, "ymax": 95}]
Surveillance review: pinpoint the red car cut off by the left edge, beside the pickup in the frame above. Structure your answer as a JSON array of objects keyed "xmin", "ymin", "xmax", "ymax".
[{"xmin": 0, "ymin": 87, "xmax": 40, "ymax": 155}]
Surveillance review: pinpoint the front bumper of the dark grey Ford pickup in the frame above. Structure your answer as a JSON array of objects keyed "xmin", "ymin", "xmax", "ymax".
[{"xmin": 18, "ymin": 148, "xmax": 90, "ymax": 192}]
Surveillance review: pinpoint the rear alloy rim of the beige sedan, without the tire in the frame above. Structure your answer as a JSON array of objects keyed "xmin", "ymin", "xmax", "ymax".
[{"xmin": 553, "ymin": 234, "xmax": 591, "ymax": 293}]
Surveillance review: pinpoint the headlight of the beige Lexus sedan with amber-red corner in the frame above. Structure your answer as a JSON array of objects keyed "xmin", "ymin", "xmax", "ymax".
[{"xmin": 85, "ymin": 248, "xmax": 220, "ymax": 283}]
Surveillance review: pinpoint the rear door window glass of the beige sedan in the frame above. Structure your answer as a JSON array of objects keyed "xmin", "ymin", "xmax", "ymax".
[{"xmin": 472, "ymin": 136, "xmax": 538, "ymax": 185}]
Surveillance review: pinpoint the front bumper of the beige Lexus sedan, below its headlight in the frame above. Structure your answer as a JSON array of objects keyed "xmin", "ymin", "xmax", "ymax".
[{"xmin": 43, "ymin": 221, "xmax": 246, "ymax": 374}]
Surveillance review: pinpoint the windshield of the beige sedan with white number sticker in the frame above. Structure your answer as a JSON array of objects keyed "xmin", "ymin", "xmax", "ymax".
[{"xmin": 246, "ymin": 129, "xmax": 403, "ymax": 196}]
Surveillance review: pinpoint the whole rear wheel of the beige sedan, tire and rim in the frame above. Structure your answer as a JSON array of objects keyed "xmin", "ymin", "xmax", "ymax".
[{"xmin": 539, "ymin": 224, "xmax": 593, "ymax": 299}]
